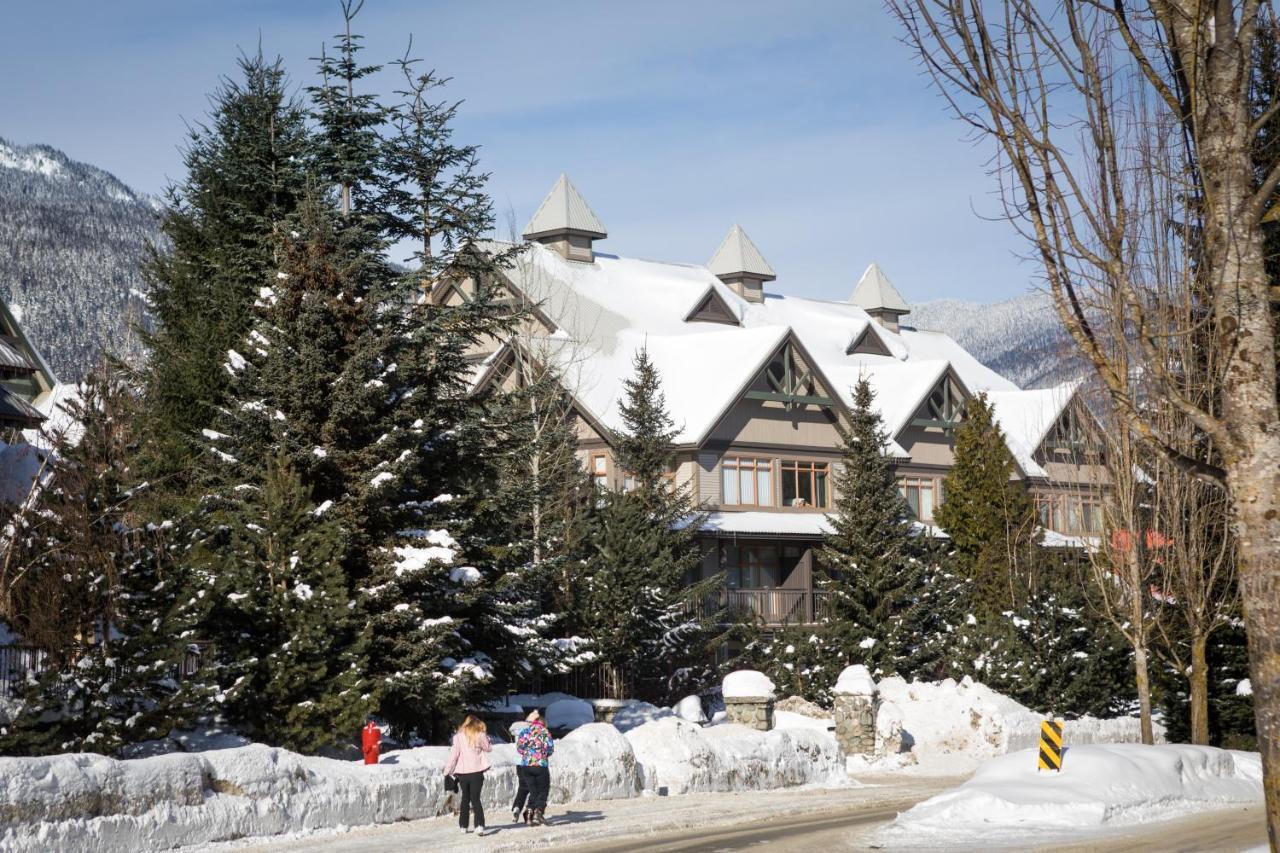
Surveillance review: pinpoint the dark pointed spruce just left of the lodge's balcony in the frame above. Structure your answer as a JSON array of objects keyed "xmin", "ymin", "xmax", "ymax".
[{"xmin": 579, "ymin": 350, "xmax": 718, "ymax": 695}]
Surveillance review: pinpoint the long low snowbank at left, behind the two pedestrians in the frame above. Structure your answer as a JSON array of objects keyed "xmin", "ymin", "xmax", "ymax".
[{"xmin": 0, "ymin": 725, "xmax": 639, "ymax": 853}]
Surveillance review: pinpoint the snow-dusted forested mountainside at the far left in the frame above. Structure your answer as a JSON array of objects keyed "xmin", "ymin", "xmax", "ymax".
[{"xmin": 0, "ymin": 138, "xmax": 160, "ymax": 382}]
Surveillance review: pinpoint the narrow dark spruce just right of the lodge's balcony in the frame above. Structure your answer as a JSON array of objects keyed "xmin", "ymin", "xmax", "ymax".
[{"xmin": 818, "ymin": 378, "xmax": 925, "ymax": 675}]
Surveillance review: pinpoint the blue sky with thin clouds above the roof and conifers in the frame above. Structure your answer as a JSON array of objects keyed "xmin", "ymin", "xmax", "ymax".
[{"xmin": 0, "ymin": 0, "xmax": 1033, "ymax": 301}]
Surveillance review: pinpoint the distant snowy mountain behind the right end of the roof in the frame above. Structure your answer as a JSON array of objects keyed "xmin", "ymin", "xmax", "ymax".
[{"xmin": 904, "ymin": 292, "xmax": 1087, "ymax": 388}]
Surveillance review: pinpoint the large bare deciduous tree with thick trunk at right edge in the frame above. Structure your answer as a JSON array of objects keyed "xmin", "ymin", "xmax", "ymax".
[{"xmin": 890, "ymin": 0, "xmax": 1280, "ymax": 848}]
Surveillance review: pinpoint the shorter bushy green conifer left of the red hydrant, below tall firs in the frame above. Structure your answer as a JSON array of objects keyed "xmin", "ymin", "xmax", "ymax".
[{"xmin": 197, "ymin": 460, "xmax": 371, "ymax": 752}]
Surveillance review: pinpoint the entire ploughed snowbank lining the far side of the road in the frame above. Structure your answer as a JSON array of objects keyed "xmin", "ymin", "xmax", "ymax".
[{"xmin": 0, "ymin": 679, "xmax": 1172, "ymax": 853}]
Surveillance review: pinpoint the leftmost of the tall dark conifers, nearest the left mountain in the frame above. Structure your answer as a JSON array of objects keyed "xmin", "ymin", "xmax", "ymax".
[{"xmin": 142, "ymin": 53, "xmax": 308, "ymax": 494}]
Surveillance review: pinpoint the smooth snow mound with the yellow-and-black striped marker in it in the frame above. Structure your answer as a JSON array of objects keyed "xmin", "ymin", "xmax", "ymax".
[{"xmin": 884, "ymin": 744, "xmax": 1262, "ymax": 847}]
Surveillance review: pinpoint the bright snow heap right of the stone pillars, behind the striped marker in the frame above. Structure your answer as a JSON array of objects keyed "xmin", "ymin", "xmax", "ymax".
[{"xmin": 879, "ymin": 678, "xmax": 1165, "ymax": 763}]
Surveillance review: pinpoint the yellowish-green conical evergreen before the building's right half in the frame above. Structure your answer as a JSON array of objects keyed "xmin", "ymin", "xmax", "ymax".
[{"xmin": 933, "ymin": 394, "xmax": 1039, "ymax": 616}]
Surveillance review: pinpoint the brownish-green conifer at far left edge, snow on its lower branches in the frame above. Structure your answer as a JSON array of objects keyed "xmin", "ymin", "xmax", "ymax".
[{"xmin": 0, "ymin": 369, "xmax": 200, "ymax": 754}]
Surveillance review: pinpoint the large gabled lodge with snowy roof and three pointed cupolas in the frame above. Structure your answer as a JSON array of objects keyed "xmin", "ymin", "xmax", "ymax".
[{"xmin": 445, "ymin": 175, "xmax": 1098, "ymax": 624}]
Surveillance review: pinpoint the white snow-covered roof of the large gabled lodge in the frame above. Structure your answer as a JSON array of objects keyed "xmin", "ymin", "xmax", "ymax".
[{"xmin": 500, "ymin": 234, "xmax": 1070, "ymax": 466}]
